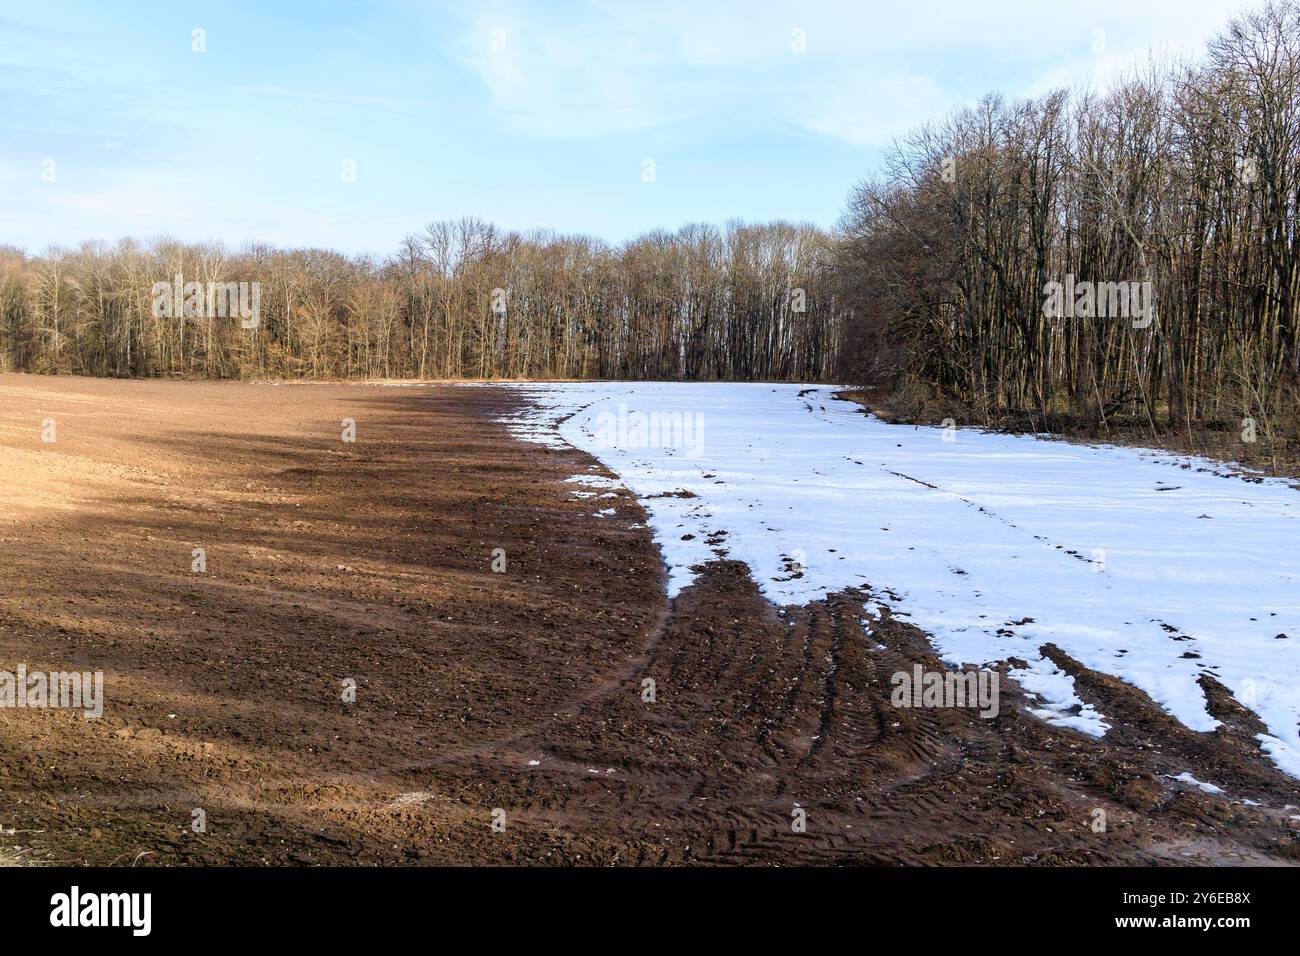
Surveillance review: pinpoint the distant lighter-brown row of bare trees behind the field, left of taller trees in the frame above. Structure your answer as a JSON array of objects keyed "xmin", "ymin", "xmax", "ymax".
[{"xmin": 0, "ymin": 219, "xmax": 839, "ymax": 380}]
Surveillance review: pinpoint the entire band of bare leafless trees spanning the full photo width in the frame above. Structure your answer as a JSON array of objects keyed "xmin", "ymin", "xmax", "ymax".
[{"xmin": 0, "ymin": 0, "xmax": 1300, "ymax": 463}]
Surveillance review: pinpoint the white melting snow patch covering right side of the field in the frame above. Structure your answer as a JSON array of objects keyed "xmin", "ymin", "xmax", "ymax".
[{"xmin": 491, "ymin": 382, "xmax": 1300, "ymax": 777}]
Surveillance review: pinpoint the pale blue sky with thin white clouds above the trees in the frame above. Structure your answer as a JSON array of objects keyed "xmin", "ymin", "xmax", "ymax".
[{"xmin": 0, "ymin": 0, "xmax": 1255, "ymax": 256}]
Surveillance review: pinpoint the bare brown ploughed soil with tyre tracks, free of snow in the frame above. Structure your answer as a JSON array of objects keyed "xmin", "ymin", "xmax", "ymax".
[{"xmin": 0, "ymin": 375, "xmax": 1300, "ymax": 865}]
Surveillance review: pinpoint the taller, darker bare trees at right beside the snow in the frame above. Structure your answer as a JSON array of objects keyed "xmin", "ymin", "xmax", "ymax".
[{"xmin": 837, "ymin": 1, "xmax": 1300, "ymax": 447}]
